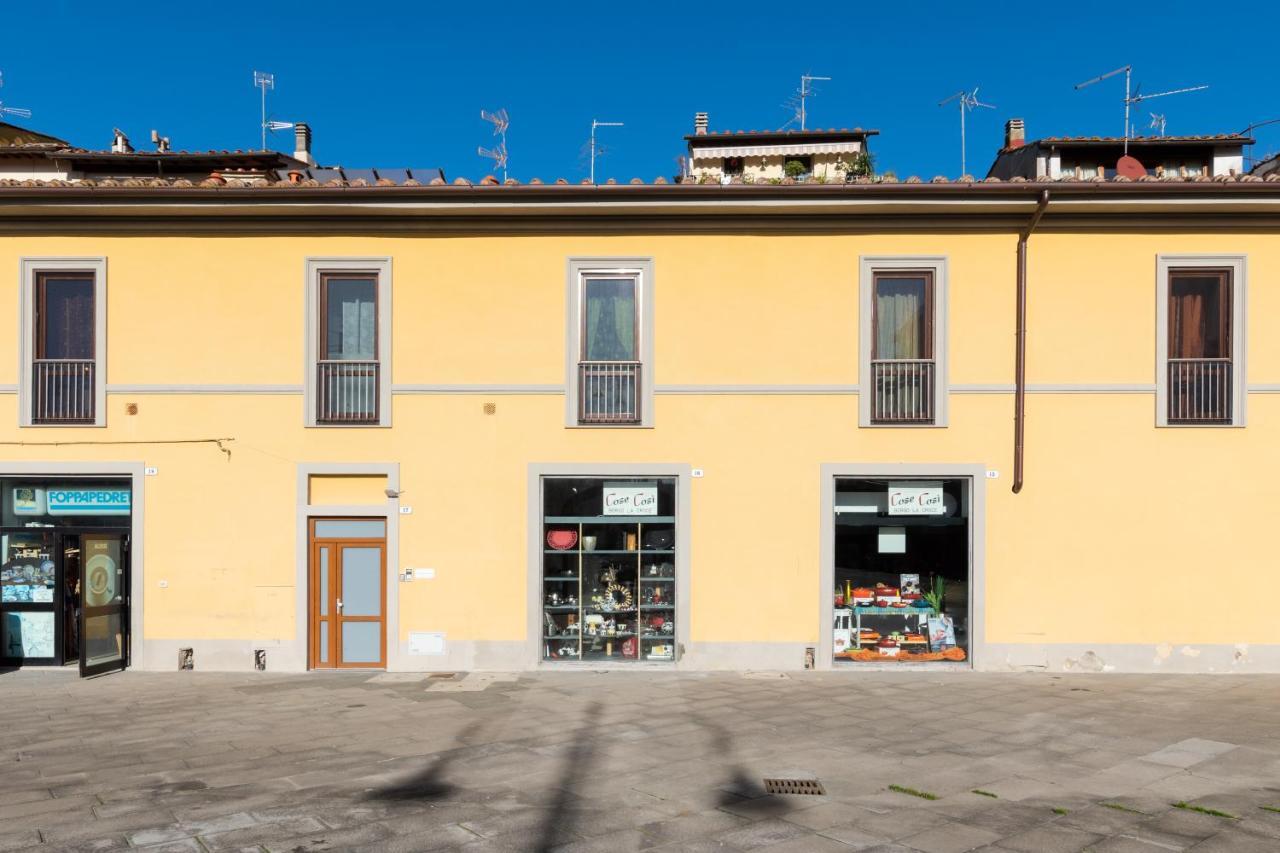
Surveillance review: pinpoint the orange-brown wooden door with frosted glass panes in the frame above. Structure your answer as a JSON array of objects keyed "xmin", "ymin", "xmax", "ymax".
[{"xmin": 308, "ymin": 519, "xmax": 387, "ymax": 670}]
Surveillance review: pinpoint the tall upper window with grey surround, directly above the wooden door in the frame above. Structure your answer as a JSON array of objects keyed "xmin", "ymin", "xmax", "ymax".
[{"xmin": 307, "ymin": 253, "xmax": 390, "ymax": 427}]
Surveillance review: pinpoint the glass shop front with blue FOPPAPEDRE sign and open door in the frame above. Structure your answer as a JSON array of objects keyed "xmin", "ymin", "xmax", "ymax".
[{"xmin": 0, "ymin": 478, "xmax": 132, "ymax": 675}]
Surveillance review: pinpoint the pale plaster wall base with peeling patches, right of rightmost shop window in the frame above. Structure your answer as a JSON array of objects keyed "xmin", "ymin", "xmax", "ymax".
[{"xmin": 977, "ymin": 643, "xmax": 1280, "ymax": 672}]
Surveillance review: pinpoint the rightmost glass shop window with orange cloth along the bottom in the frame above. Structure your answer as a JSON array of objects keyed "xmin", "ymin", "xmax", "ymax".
[{"xmin": 832, "ymin": 478, "xmax": 970, "ymax": 665}]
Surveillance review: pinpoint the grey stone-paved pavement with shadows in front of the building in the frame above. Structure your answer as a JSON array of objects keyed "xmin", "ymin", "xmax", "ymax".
[{"xmin": 0, "ymin": 669, "xmax": 1280, "ymax": 853}]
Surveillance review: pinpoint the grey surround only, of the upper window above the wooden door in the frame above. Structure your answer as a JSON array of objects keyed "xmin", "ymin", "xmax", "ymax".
[{"xmin": 302, "ymin": 257, "xmax": 392, "ymax": 429}]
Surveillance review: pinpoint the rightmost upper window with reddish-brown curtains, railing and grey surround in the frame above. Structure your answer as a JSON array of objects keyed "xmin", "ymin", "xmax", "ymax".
[{"xmin": 1157, "ymin": 252, "xmax": 1244, "ymax": 427}]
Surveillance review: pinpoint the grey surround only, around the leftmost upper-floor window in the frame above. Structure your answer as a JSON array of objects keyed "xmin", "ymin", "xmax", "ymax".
[{"xmin": 18, "ymin": 256, "xmax": 106, "ymax": 429}]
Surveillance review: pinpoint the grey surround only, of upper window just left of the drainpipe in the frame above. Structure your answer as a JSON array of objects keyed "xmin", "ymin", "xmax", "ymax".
[{"xmin": 858, "ymin": 255, "xmax": 951, "ymax": 429}]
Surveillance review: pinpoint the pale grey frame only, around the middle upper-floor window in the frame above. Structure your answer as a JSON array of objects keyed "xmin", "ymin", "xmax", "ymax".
[{"xmin": 564, "ymin": 257, "xmax": 654, "ymax": 429}]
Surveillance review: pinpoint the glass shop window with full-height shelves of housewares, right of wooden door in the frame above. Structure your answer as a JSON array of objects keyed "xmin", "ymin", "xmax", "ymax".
[{"xmin": 541, "ymin": 476, "xmax": 678, "ymax": 662}]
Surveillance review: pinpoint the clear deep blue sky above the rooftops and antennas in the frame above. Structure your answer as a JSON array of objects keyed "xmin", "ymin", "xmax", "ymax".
[{"xmin": 10, "ymin": 0, "xmax": 1280, "ymax": 181}]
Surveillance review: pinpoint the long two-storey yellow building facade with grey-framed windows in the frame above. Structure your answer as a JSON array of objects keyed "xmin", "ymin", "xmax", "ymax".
[{"xmin": 0, "ymin": 181, "xmax": 1280, "ymax": 672}]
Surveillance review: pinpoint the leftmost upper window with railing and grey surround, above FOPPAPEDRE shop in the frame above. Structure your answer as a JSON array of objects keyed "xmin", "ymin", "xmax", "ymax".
[{"xmin": 19, "ymin": 253, "xmax": 106, "ymax": 427}]
